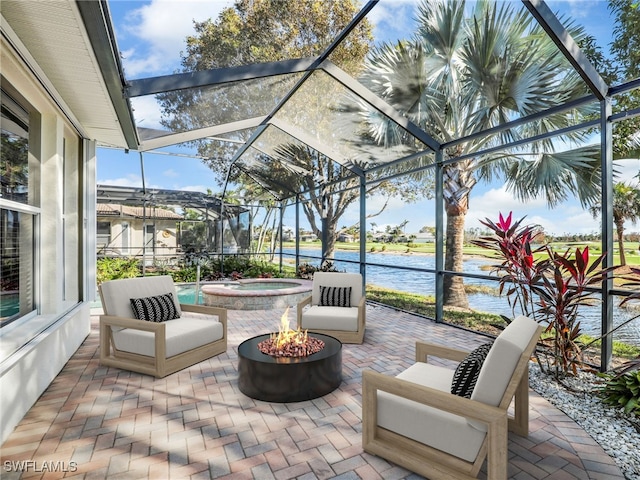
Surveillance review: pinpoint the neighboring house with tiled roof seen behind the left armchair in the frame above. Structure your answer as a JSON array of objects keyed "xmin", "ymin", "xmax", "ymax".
[{"xmin": 96, "ymin": 203, "xmax": 184, "ymax": 263}]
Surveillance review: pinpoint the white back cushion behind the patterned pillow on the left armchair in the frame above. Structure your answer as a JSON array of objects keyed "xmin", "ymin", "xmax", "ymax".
[{"xmin": 100, "ymin": 275, "xmax": 182, "ymax": 318}]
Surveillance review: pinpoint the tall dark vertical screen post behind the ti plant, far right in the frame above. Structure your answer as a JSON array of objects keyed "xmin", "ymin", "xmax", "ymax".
[{"xmin": 600, "ymin": 96, "xmax": 613, "ymax": 372}]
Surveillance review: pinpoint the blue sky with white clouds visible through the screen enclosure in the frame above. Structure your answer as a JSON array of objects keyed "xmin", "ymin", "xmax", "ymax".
[{"xmin": 98, "ymin": 0, "xmax": 640, "ymax": 235}]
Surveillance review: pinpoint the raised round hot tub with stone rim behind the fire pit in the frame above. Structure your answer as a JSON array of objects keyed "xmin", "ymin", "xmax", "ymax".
[{"xmin": 201, "ymin": 278, "xmax": 311, "ymax": 310}]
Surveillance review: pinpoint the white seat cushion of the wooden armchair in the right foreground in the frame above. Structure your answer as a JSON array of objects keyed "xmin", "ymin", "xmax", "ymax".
[{"xmin": 378, "ymin": 362, "xmax": 486, "ymax": 462}]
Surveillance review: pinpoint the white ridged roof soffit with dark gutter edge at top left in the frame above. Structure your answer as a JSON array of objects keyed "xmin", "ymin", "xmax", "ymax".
[{"xmin": 2, "ymin": 0, "xmax": 137, "ymax": 148}]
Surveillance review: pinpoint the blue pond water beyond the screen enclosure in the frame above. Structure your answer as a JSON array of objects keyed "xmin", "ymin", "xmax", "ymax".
[{"xmin": 283, "ymin": 249, "xmax": 640, "ymax": 346}]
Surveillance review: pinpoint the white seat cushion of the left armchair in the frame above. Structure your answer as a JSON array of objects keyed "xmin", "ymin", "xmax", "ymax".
[{"xmin": 113, "ymin": 312, "xmax": 224, "ymax": 358}]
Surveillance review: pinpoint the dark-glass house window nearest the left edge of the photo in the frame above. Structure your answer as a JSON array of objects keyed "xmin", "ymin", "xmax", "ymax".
[{"xmin": 0, "ymin": 90, "xmax": 39, "ymax": 326}]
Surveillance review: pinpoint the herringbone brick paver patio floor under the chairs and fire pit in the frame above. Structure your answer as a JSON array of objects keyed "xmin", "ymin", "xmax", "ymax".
[{"xmin": 0, "ymin": 305, "xmax": 624, "ymax": 480}]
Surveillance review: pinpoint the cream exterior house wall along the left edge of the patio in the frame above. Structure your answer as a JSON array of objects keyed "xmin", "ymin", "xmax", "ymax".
[{"xmin": 0, "ymin": 31, "xmax": 96, "ymax": 442}]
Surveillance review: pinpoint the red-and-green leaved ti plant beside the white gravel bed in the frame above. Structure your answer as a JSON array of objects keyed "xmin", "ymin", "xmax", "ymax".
[{"xmin": 473, "ymin": 213, "xmax": 612, "ymax": 375}]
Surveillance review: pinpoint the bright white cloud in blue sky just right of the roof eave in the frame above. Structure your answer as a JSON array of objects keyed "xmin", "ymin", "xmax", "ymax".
[{"xmin": 120, "ymin": 0, "xmax": 233, "ymax": 78}]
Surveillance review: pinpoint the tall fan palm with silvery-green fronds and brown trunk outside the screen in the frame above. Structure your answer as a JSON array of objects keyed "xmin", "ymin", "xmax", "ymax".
[{"xmin": 361, "ymin": 0, "xmax": 599, "ymax": 307}]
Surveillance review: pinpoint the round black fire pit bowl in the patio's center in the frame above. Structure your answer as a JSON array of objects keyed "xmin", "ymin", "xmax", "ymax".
[{"xmin": 238, "ymin": 332, "xmax": 342, "ymax": 403}]
